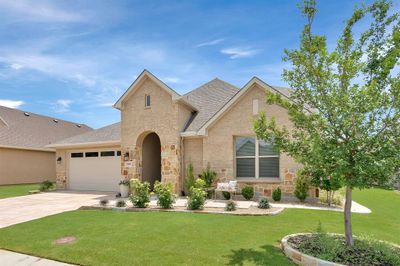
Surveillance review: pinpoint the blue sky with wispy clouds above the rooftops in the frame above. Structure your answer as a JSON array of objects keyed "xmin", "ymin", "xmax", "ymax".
[{"xmin": 0, "ymin": 0, "xmax": 388, "ymax": 128}]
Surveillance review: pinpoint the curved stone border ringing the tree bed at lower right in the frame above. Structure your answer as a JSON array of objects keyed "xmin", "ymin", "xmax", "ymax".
[{"xmin": 281, "ymin": 233, "xmax": 344, "ymax": 266}]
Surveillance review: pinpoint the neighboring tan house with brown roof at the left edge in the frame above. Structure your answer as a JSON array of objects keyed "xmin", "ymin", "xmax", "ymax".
[{"xmin": 0, "ymin": 106, "xmax": 92, "ymax": 185}]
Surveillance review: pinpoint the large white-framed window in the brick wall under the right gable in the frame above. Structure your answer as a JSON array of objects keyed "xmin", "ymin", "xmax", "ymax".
[{"xmin": 235, "ymin": 137, "xmax": 279, "ymax": 178}]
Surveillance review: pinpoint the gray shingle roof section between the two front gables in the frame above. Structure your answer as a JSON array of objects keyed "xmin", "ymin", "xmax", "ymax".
[{"xmin": 183, "ymin": 78, "xmax": 239, "ymax": 131}]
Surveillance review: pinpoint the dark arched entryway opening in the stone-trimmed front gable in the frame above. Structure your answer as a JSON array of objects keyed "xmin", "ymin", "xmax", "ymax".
[{"xmin": 142, "ymin": 132, "xmax": 161, "ymax": 190}]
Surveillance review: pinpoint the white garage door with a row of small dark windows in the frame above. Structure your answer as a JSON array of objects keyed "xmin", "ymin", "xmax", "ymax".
[{"xmin": 69, "ymin": 150, "xmax": 121, "ymax": 191}]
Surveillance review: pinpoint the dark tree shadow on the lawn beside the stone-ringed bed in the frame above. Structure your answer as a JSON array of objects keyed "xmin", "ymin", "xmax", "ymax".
[{"xmin": 227, "ymin": 245, "xmax": 291, "ymax": 265}]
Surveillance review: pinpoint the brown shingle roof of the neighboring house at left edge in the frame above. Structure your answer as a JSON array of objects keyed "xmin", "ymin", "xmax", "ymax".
[{"xmin": 0, "ymin": 106, "xmax": 92, "ymax": 152}]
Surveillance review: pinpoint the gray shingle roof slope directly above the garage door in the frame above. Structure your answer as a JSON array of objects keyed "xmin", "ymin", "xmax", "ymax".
[{"xmin": 54, "ymin": 123, "xmax": 121, "ymax": 145}]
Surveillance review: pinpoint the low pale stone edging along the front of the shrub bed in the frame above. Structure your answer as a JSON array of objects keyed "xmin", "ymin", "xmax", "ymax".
[{"xmin": 79, "ymin": 206, "xmax": 284, "ymax": 216}]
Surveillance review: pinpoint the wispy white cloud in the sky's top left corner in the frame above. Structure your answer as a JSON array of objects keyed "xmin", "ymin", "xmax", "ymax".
[{"xmin": 0, "ymin": 0, "xmax": 84, "ymax": 22}]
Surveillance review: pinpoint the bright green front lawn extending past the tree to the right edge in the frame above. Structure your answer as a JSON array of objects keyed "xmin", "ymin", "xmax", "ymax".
[{"xmin": 0, "ymin": 189, "xmax": 400, "ymax": 265}]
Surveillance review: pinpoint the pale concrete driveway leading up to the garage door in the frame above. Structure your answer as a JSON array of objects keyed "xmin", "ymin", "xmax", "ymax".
[{"xmin": 0, "ymin": 191, "xmax": 112, "ymax": 228}]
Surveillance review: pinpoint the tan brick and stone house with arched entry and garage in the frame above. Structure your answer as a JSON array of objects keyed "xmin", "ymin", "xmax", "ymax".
[{"xmin": 49, "ymin": 70, "xmax": 312, "ymax": 196}]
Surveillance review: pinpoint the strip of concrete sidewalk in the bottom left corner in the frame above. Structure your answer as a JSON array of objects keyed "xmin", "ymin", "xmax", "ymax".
[{"xmin": 0, "ymin": 249, "xmax": 72, "ymax": 266}]
